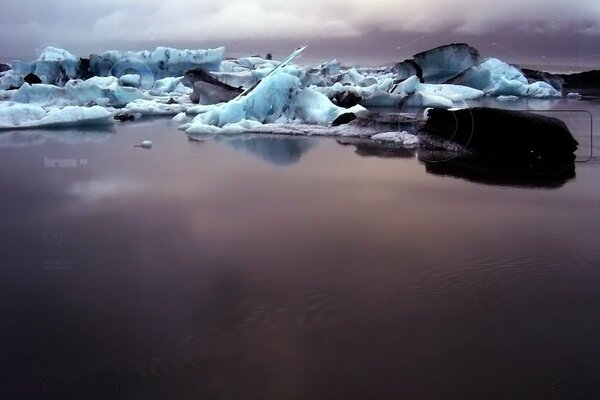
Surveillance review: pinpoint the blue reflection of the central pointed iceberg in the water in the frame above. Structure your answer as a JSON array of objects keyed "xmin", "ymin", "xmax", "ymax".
[{"xmin": 218, "ymin": 134, "xmax": 313, "ymax": 166}]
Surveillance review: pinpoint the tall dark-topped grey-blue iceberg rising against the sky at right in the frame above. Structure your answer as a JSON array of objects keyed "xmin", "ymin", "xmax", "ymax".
[{"xmin": 413, "ymin": 43, "xmax": 480, "ymax": 83}]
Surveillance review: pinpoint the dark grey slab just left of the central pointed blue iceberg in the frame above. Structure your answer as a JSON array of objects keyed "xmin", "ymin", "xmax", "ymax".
[{"xmin": 184, "ymin": 68, "xmax": 243, "ymax": 104}]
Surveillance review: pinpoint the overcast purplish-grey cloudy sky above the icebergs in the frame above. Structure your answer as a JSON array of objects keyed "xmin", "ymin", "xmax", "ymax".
[{"xmin": 0, "ymin": 0, "xmax": 600, "ymax": 66}]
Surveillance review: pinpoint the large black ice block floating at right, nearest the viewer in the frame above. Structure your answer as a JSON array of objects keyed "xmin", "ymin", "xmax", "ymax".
[{"xmin": 421, "ymin": 107, "xmax": 578, "ymax": 169}]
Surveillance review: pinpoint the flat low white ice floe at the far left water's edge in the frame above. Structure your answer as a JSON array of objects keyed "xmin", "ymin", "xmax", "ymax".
[{"xmin": 0, "ymin": 104, "xmax": 114, "ymax": 129}]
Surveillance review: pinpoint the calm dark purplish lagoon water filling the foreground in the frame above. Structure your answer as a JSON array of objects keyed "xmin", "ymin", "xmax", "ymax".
[{"xmin": 0, "ymin": 105, "xmax": 600, "ymax": 399}]
